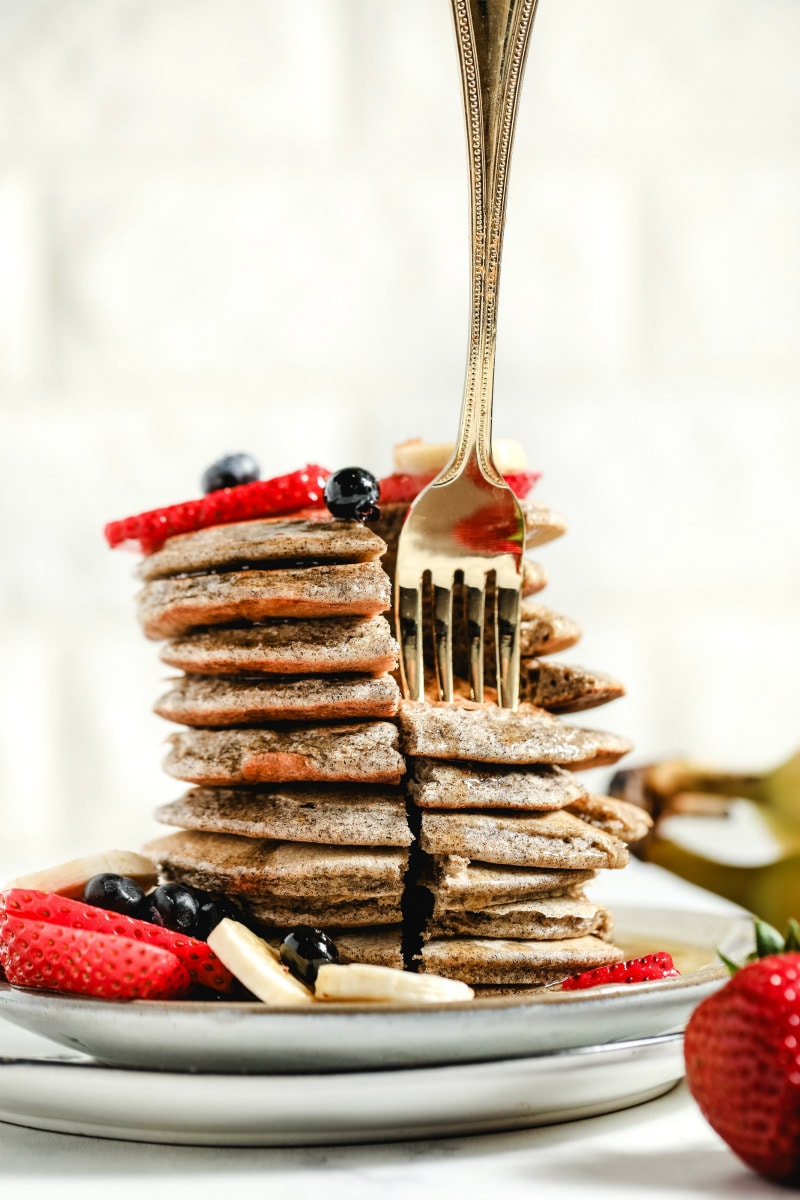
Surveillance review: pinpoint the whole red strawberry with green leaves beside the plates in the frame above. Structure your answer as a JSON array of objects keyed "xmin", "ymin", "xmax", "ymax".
[{"xmin": 685, "ymin": 922, "xmax": 800, "ymax": 1184}]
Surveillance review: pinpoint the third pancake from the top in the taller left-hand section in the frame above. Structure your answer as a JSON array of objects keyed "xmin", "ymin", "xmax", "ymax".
[{"xmin": 161, "ymin": 617, "xmax": 398, "ymax": 676}]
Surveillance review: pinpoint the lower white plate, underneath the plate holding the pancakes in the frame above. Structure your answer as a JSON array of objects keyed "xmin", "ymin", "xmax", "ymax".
[{"xmin": 0, "ymin": 1033, "xmax": 684, "ymax": 1146}]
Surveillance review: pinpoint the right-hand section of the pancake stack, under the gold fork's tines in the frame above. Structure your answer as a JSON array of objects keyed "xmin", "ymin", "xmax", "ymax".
[{"xmin": 379, "ymin": 500, "xmax": 649, "ymax": 994}]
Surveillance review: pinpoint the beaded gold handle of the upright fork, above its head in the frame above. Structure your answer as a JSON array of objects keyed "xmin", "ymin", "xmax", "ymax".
[{"xmin": 448, "ymin": 0, "xmax": 537, "ymax": 485}]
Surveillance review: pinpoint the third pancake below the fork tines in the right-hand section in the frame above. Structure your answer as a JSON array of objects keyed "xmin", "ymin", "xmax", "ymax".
[{"xmin": 420, "ymin": 810, "xmax": 628, "ymax": 870}]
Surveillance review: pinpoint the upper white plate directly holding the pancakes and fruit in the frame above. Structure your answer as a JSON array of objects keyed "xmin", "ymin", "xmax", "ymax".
[{"xmin": 0, "ymin": 907, "xmax": 752, "ymax": 1087}]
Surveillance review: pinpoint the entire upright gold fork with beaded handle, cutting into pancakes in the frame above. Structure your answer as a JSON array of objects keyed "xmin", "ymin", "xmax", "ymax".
[{"xmin": 395, "ymin": 0, "xmax": 537, "ymax": 708}]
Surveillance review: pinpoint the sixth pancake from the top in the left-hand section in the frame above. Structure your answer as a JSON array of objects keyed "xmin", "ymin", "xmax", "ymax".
[{"xmin": 156, "ymin": 785, "xmax": 414, "ymax": 846}]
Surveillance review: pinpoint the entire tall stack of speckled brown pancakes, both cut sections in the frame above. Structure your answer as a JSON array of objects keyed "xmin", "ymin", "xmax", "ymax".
[{"xmin": 128, "ymin": 482, "xmax": 648, "ymax": 992}]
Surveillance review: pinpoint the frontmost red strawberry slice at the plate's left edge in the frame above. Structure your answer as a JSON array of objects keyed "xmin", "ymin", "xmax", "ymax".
[{"xmin": 2, "ymin": 914, "xmax": 191, "ymax": 1000}]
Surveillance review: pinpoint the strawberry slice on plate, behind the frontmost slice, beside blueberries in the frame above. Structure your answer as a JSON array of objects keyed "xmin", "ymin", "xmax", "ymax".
[{"xmin": 0, "ymin": 888, "xmax": 234, "ymax": 991}]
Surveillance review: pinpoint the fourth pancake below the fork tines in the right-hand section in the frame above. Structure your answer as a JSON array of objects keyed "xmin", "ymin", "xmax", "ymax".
[{"xmin": 421, "ymin": 854, "xmax": 596, "ymax": 917}]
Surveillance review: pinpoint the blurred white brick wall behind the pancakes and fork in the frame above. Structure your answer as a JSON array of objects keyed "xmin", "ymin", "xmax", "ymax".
[{"xmin": 0, "ymin": 0, "xmax": 800, "ymax": 868}]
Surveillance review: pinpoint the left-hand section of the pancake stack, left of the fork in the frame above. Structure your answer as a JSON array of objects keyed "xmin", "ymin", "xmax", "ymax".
[{"xmin": 138, "ymin": 517, "xmax": 413, "ymax": 966}]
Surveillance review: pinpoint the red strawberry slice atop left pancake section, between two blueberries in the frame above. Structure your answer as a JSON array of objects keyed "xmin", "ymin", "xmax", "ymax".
[{"xmin": 104, "ymin": 466, "xmax": 330, "ymax": 554}]
